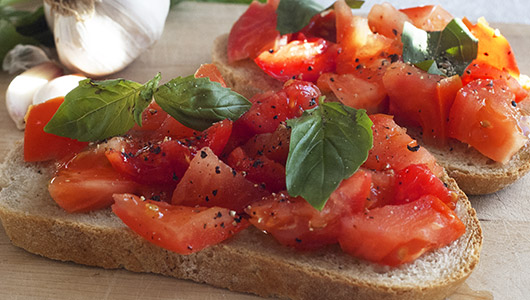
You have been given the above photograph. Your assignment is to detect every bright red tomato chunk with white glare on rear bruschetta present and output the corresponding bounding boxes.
[254,38,338,82]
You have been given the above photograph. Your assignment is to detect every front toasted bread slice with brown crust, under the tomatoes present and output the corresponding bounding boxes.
[0,143,482,300]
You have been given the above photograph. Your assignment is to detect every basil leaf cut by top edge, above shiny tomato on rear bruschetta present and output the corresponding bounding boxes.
[276,0,364,35]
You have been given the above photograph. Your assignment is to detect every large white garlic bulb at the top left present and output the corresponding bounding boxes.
[44,0,170,77]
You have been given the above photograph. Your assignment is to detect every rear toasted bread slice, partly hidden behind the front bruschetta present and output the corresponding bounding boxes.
[212,35,530,195]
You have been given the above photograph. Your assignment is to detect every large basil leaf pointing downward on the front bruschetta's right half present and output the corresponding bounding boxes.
[285,102,373,210]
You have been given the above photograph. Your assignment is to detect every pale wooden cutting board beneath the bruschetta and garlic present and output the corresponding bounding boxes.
[0,3,530,300]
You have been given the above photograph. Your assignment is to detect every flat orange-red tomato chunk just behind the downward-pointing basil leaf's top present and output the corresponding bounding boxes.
[317,73,387,114]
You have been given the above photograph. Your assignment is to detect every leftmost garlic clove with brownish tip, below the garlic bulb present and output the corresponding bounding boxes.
[6,62,63,130]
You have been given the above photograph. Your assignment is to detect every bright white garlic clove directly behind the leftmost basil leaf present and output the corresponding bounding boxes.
[33,75,86,105]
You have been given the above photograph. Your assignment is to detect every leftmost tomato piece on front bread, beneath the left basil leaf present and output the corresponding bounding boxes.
[24,97,88,161]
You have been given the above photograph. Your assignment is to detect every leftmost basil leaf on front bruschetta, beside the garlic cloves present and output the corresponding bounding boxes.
[44,79,145,141]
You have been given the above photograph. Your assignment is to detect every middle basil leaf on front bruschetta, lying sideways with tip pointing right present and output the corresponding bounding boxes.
[154,76,252,131]
